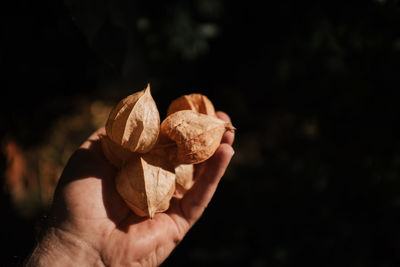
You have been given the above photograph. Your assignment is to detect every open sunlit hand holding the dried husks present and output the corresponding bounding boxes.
[27,112,234,266]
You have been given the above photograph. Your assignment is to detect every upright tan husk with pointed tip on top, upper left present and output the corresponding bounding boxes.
[106,85,160,153]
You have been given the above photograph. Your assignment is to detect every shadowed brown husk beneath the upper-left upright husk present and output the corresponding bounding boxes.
[100,135,134,169]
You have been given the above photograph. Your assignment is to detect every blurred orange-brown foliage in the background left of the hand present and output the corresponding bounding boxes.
[3,101,111,217]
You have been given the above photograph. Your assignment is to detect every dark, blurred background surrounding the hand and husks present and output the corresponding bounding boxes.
[0,0,400,267]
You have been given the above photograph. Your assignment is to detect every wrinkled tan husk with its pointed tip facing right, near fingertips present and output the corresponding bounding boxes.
[161,110,235,165]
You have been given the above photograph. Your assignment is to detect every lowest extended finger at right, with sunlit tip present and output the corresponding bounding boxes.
[181,144,234,226]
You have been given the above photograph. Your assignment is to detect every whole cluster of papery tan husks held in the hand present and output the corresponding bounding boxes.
[101,85,235,218]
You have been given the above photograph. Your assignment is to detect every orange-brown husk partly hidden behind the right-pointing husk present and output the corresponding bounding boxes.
[167,94,215,116]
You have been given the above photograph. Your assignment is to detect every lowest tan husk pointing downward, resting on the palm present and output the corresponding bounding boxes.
[116,153,175,218]
